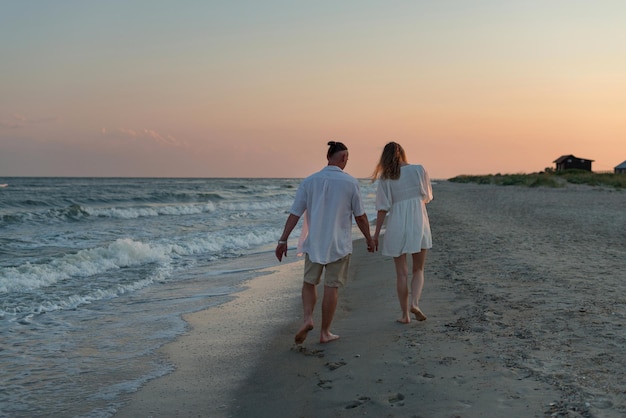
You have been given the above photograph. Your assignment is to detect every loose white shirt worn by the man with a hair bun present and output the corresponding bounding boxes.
[290,165,365,264]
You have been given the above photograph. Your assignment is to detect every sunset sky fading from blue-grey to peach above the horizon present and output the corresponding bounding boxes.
[0,0,626,178]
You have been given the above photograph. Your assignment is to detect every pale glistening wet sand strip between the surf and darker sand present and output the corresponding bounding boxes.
[114,258,304,418]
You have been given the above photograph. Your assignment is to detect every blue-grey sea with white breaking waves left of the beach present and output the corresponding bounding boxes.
[0,177,375,417]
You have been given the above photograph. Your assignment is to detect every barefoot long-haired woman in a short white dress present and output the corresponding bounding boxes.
[372,142,433,324]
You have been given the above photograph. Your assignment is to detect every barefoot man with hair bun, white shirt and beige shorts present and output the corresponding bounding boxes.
[276,141,374,344]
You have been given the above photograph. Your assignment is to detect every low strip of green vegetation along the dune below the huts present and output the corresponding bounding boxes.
[449,168,626,189]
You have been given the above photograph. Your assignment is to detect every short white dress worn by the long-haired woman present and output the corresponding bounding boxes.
[376,164,433,257]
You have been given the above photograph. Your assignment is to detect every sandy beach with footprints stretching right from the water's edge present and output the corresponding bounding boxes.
[115,182,626,418]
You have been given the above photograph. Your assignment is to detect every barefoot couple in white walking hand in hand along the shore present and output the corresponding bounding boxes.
[276,141,433,344]
